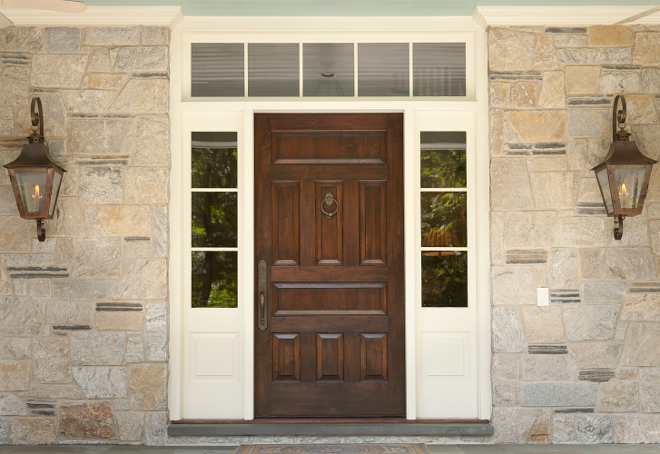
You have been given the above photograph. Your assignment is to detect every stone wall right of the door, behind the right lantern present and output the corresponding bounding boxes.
[489,26,660,443]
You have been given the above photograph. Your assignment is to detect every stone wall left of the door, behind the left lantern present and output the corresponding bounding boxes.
[0,26,170,444]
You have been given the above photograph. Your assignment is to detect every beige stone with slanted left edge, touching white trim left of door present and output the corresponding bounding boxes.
[109,78,169,113]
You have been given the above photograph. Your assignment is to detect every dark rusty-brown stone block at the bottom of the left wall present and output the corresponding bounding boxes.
[58,401,116,438]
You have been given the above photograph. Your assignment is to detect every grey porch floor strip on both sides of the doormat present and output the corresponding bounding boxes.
[0,444,660,454]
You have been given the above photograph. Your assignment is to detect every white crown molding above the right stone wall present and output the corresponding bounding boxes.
[472,5,660,30]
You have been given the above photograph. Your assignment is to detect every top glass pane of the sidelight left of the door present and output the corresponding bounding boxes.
[191,132,238,188]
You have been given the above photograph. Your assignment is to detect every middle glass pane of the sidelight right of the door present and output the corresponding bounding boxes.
[420,192,467,247]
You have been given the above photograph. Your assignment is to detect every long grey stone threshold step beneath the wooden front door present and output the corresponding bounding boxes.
[167,418,494,436]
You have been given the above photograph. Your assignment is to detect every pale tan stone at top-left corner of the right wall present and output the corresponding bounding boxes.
[488,27,536,71]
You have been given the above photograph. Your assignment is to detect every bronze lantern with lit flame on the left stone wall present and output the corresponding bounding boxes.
[5,98,66,241]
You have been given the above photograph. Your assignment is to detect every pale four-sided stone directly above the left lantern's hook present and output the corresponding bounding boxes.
[30,54,88,88]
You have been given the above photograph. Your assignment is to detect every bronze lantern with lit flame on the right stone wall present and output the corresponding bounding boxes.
[591,95,657,240]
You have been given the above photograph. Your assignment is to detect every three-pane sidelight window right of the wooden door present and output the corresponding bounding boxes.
[420,132,468,307]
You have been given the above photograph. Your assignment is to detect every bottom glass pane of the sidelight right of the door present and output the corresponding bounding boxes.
[422,251,468,307]
